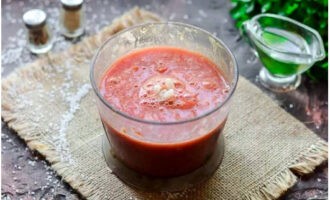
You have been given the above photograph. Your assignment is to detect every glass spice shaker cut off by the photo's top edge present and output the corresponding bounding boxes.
[60,0,85,38]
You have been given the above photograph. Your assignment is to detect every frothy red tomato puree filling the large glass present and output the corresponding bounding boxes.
[100,47,229,177]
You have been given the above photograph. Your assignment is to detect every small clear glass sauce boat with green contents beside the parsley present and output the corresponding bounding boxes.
[242,14,325,92]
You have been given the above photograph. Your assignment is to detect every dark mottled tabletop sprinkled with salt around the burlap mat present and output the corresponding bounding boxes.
[1,0,328,200]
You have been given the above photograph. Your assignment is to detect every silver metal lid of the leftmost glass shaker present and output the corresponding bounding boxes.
[23,9,47,28]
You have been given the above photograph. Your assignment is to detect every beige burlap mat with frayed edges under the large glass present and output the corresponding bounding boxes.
[2,8,327,200]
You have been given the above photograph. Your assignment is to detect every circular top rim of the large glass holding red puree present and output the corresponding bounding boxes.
[90,22,238,125]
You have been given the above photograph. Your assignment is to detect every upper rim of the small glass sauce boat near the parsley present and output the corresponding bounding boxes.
[243,13,325,61]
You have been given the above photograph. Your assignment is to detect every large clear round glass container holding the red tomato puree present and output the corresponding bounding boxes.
[90,22,238,191]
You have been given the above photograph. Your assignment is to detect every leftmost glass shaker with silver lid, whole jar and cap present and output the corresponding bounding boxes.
[23,9,53,54]
